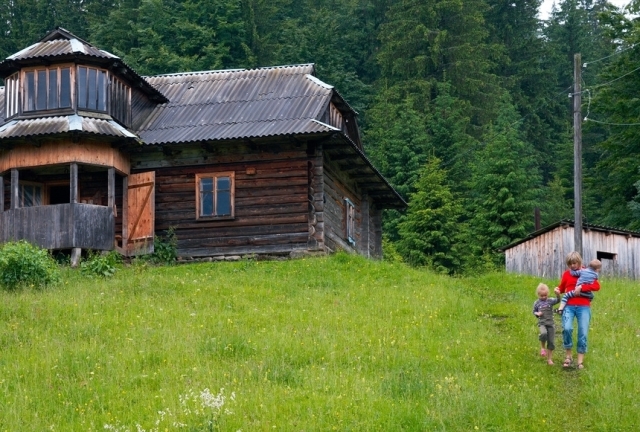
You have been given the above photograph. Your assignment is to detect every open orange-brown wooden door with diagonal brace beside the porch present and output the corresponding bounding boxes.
[122,171,156,256]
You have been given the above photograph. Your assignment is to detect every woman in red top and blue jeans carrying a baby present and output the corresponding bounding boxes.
[554,252,600,369]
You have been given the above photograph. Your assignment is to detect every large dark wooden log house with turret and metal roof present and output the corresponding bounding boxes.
[0,28,406,257]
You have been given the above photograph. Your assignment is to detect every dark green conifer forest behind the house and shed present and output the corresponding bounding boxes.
[0,0,640,273]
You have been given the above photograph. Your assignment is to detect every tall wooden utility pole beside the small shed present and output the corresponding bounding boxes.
[573,53,582,256]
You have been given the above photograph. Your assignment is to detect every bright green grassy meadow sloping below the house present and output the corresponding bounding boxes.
[0,254,640,432]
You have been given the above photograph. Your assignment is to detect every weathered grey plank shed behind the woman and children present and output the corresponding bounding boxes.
[503,220,640,279]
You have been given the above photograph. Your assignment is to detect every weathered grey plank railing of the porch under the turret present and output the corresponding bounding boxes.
[0,203,115,250]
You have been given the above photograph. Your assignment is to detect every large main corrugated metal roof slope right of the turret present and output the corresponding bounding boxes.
[137,64,336,144]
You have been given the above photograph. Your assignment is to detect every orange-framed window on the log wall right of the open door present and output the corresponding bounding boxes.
[196,172,235,219]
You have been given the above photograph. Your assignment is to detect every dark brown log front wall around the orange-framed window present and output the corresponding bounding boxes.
[131,143,309,257]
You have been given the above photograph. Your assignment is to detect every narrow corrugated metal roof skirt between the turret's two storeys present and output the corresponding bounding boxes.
[0,114,136,139]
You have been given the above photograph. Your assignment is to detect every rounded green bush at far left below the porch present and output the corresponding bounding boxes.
[0,240,60,289]
